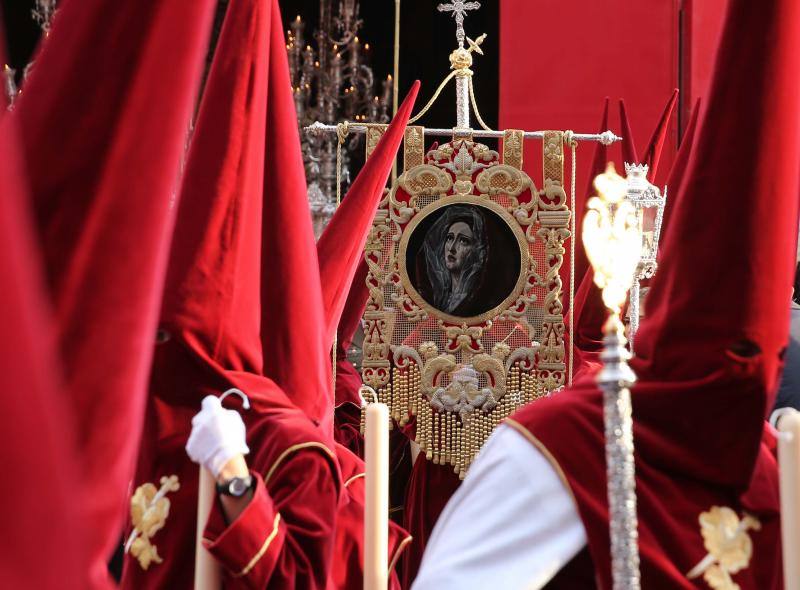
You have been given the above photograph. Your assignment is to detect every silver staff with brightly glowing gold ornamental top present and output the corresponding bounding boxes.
[583,163,642,590]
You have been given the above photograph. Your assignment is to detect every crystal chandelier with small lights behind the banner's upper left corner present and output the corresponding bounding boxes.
[286,0,393,237]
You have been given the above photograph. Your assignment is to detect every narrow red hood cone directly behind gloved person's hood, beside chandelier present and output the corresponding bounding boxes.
[261,0,333,430]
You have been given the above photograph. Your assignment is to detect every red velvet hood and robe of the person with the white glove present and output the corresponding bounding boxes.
[123,0,341,589]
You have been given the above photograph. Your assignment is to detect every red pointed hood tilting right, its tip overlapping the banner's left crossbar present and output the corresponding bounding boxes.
[317,80,419,347]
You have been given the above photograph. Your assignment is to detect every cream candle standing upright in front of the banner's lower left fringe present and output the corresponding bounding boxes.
[364,403,389,590]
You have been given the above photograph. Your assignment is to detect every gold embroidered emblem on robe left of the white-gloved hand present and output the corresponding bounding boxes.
[125,475,181,570]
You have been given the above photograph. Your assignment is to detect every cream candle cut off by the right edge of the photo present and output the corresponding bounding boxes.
[778,410,800,590]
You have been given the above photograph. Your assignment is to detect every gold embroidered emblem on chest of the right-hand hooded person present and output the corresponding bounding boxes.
[686,506,761,590]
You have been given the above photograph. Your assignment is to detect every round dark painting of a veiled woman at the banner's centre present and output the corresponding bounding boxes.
[403,202,527,319]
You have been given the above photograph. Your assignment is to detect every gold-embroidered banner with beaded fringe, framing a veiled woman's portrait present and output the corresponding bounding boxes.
[362,132,570,477]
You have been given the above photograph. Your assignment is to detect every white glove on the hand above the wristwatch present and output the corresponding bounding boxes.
[186,395,250,477]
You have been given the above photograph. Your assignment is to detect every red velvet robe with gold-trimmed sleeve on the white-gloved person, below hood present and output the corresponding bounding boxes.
[122,342,341,590]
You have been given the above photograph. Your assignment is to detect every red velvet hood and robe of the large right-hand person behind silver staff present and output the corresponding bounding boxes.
[512,0,800,589]
